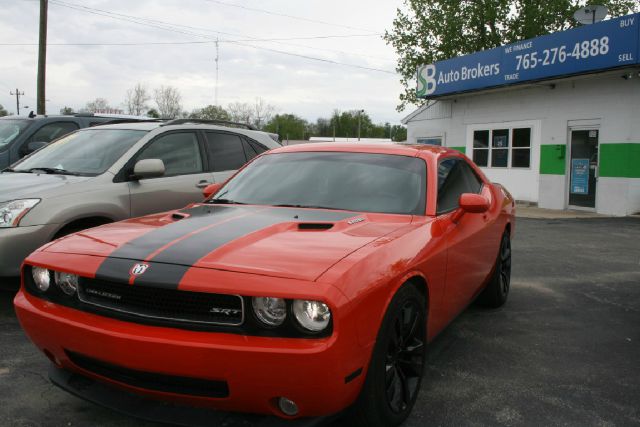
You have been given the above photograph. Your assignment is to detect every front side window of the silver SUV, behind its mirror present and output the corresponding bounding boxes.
[137,132,204,177]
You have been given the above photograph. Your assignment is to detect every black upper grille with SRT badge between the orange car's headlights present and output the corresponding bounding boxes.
[78,278,244,326]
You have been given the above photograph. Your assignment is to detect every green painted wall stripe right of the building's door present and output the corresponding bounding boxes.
[599,143,640,178]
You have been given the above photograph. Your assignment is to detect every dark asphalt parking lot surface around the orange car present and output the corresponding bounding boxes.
[0,218,640,427]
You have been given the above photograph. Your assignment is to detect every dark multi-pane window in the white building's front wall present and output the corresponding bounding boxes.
[473,128,531,168]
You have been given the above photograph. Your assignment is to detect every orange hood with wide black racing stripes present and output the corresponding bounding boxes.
[42,204,412,286]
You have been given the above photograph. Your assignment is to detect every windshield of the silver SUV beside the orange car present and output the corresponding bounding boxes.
[13,129,147,176]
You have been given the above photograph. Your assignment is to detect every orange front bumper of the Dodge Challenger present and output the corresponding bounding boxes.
[14,290,370,418]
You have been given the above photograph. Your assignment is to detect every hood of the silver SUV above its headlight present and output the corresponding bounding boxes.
[0,172,91,202]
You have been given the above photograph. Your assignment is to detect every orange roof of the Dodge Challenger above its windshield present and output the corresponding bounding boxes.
[271,142,461,157]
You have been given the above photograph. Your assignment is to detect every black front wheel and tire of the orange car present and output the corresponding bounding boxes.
[351,284,427,427]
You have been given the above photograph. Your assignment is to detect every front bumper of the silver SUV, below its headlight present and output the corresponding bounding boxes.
[0,224,58,277]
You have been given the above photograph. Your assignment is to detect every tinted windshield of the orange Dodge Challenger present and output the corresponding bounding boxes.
[210,152,426,215]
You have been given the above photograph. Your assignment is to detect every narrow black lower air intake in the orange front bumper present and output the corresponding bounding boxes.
[66,350,229,398]
